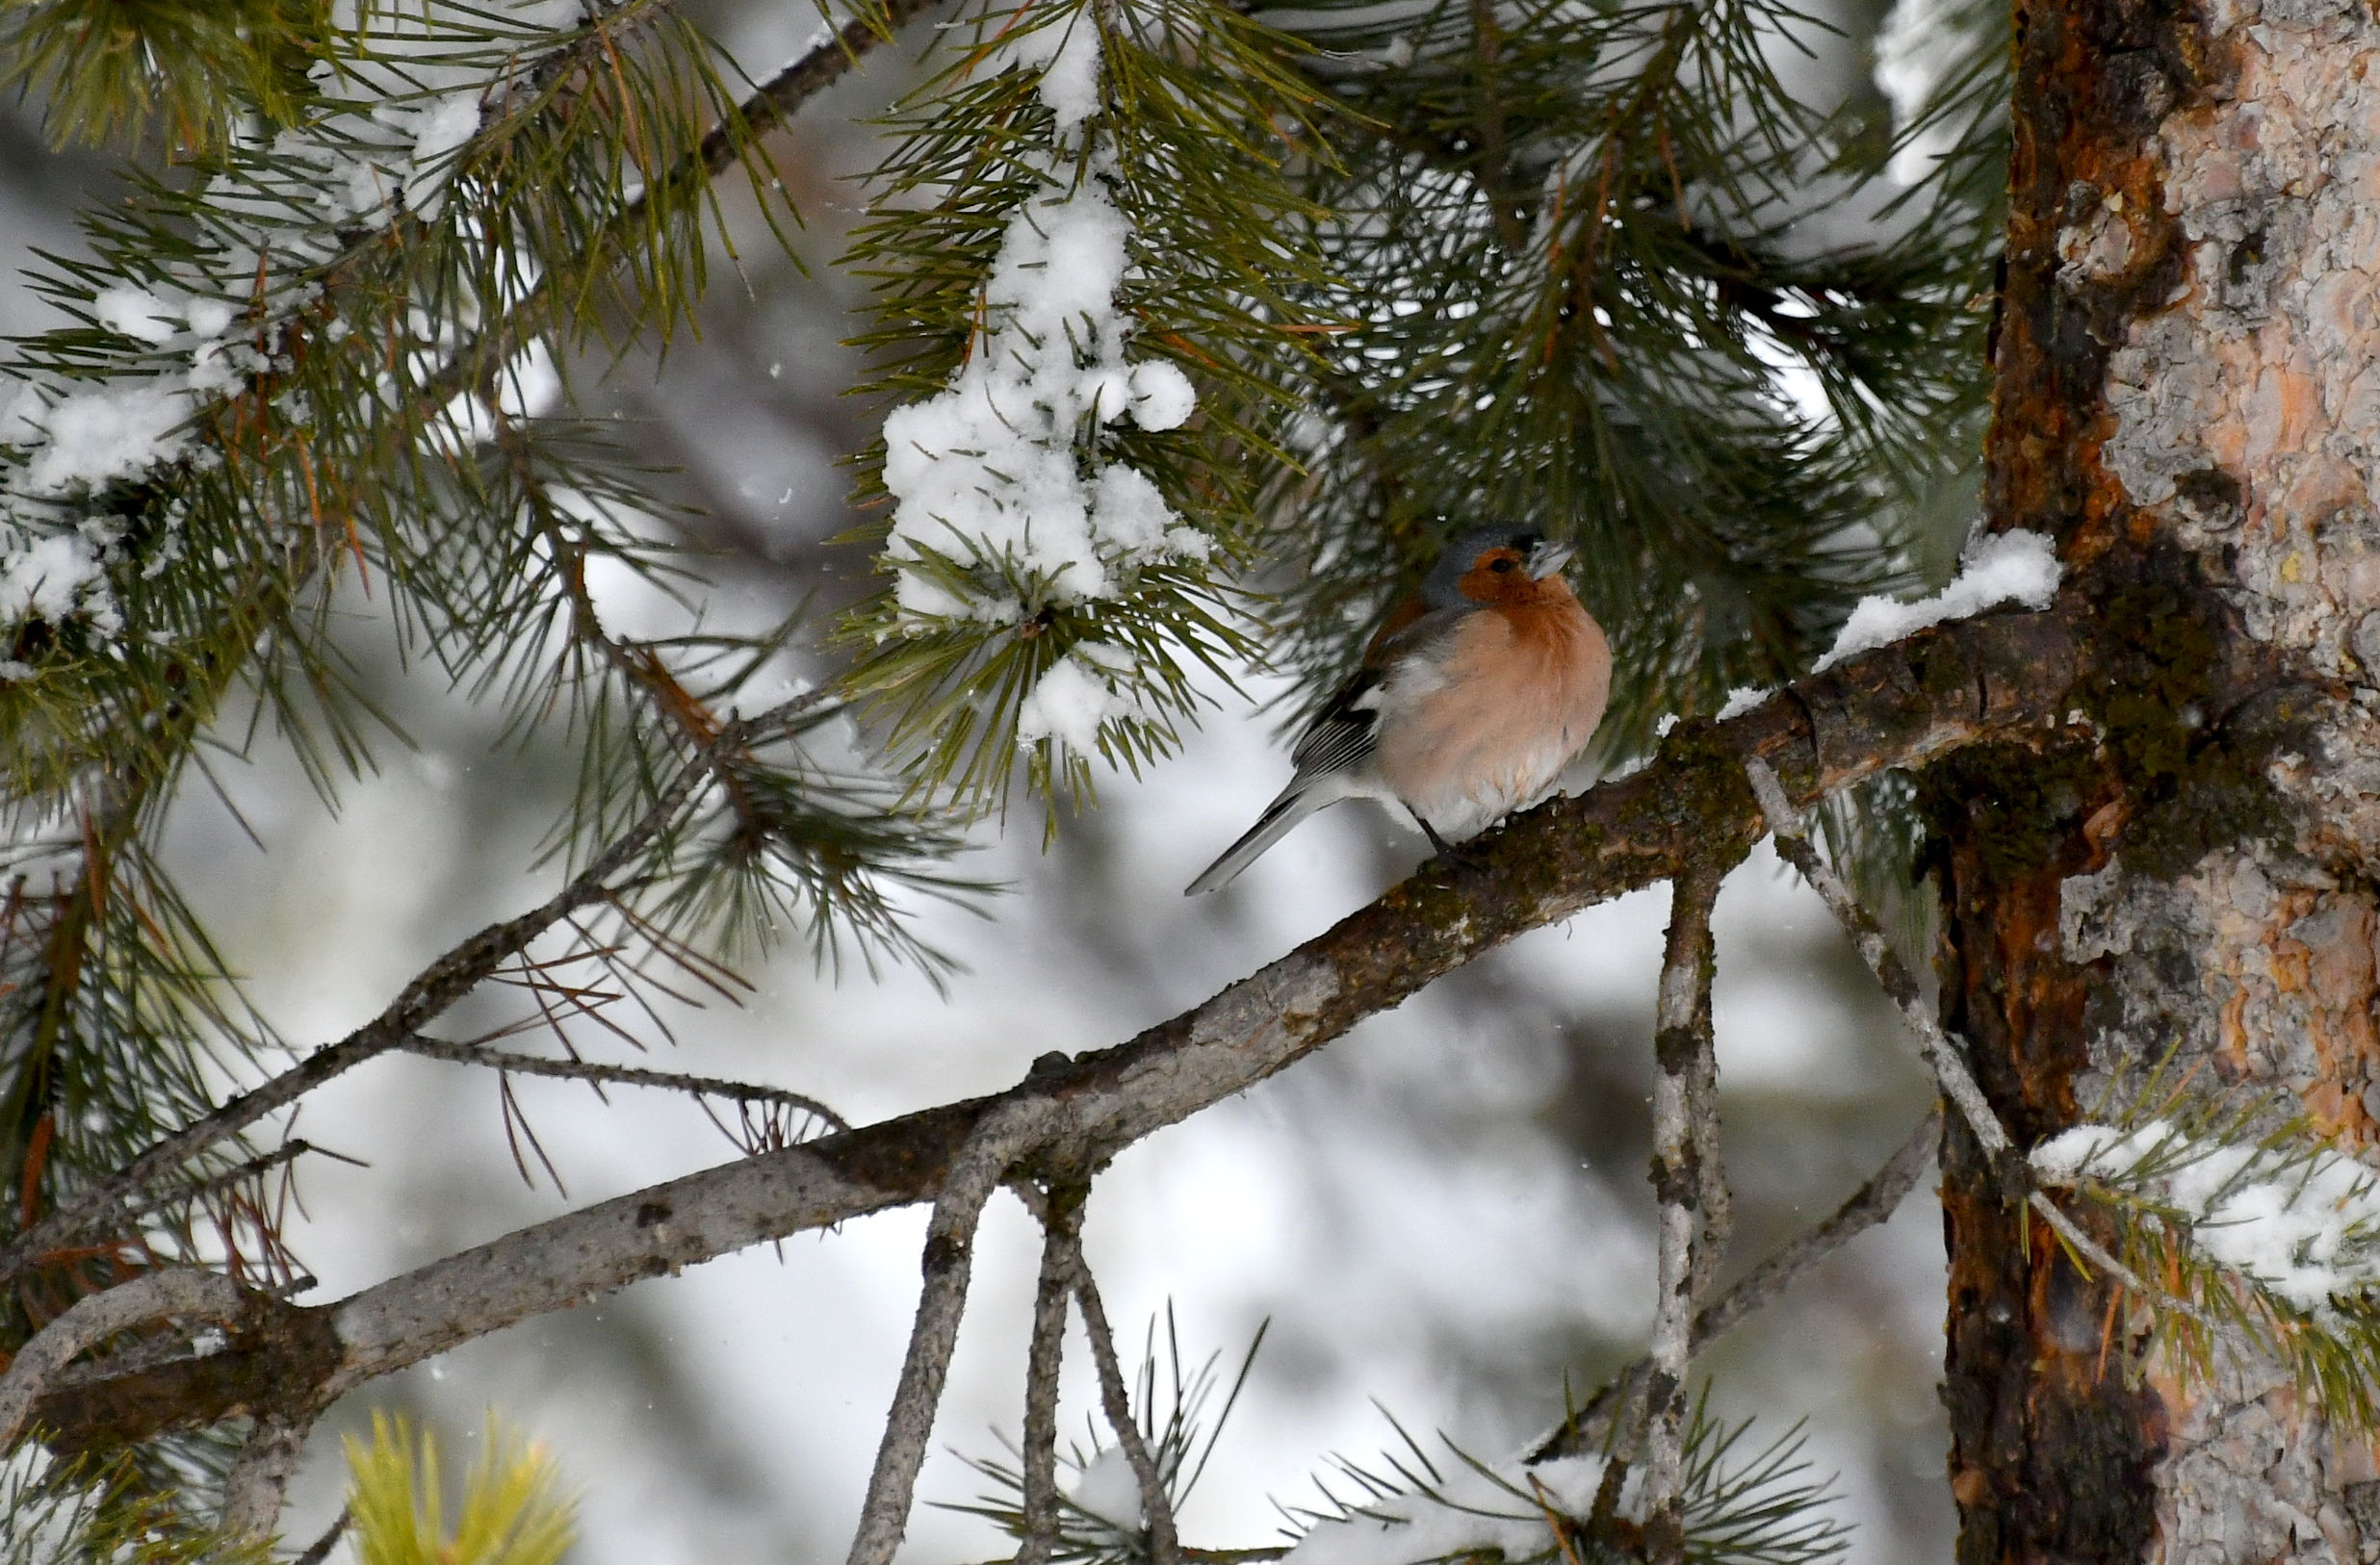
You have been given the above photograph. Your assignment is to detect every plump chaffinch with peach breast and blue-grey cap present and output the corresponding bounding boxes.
[1185,524,1612,897]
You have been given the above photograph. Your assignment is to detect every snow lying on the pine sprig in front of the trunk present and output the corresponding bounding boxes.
[2032,1120,2380,1313]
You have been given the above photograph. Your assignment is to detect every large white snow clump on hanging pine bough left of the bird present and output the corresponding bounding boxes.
[883,2,1211,752]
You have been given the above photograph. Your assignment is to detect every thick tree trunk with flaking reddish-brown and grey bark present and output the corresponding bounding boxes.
[1926,0,2380,1565]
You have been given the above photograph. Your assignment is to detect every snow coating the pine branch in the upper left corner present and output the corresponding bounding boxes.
[0,0,588,656]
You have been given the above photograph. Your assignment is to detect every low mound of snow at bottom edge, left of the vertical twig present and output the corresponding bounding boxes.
[1282,1455,1604,1565]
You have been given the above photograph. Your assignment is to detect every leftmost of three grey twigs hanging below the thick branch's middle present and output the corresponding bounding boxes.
[850,1101,1057,1565]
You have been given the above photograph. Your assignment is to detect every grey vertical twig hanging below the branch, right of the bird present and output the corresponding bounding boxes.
[1644,861,1728,1565]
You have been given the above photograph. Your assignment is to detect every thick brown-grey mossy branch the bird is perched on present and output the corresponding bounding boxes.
[42,600,2089,1437]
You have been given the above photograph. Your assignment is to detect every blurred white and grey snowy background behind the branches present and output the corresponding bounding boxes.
[0,0,1952,1565]
